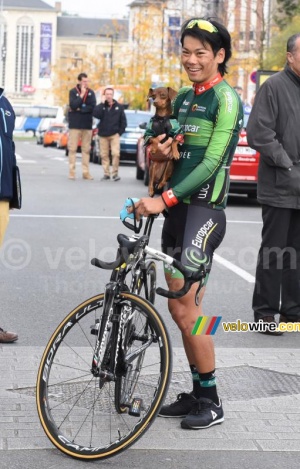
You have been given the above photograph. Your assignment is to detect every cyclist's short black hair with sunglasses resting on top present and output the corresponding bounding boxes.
[180,17,232,76]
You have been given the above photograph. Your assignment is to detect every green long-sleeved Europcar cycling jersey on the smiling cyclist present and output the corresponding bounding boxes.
[169,80,243,209]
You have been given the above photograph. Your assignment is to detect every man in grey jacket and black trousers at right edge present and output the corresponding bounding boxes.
[247,33,300,335]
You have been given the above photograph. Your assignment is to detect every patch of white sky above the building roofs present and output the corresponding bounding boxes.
[44,0,132,19]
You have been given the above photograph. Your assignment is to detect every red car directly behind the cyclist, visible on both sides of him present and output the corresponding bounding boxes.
[136,106,259,198]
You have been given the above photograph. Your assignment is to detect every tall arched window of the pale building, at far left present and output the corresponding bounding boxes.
[15,17,34,93]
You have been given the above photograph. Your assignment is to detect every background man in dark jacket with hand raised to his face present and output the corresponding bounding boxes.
[68,73,96,179]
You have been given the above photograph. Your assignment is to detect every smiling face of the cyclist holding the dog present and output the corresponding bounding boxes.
[181,36,225,83]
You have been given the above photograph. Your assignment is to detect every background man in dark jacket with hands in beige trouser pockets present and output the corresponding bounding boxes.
[93,88,127,181]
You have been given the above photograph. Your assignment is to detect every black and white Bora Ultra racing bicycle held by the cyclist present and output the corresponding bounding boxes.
[36,198,205,460]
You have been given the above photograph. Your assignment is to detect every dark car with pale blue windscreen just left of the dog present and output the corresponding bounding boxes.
[120,109,153,161]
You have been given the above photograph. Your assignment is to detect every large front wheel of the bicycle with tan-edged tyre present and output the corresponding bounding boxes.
[36,292,172,460]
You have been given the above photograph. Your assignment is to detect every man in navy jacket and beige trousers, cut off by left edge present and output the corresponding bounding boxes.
[0,88,18,343]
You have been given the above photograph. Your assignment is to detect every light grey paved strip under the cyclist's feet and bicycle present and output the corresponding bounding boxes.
[0,344,300,452]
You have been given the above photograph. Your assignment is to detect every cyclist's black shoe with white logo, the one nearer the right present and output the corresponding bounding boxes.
[181,397,224,430]
